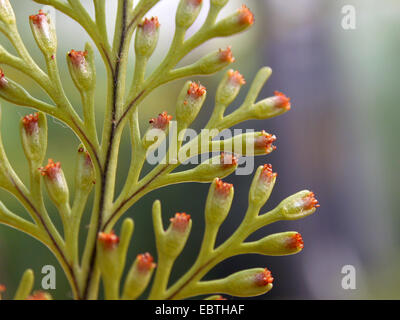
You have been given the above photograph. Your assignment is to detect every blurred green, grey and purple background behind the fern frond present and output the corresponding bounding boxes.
[0,0,400,299]
